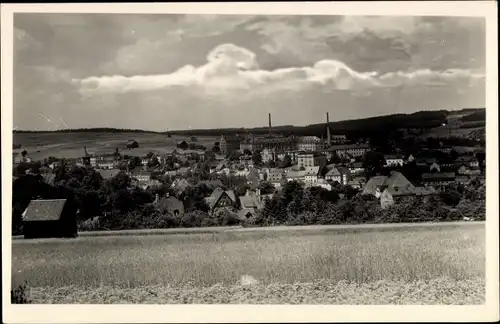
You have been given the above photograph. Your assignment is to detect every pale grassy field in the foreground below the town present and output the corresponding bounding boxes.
[12,223,485,304]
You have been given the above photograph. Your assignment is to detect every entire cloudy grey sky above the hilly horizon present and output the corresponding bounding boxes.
[13,13,486,131]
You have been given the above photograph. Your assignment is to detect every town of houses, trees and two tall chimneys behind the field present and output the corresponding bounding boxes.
[13,112,485,237]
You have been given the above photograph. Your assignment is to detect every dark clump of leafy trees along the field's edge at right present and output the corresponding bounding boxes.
[248,181,486,226]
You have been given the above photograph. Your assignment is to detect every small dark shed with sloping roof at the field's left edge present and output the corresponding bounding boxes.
[23,199,78,239]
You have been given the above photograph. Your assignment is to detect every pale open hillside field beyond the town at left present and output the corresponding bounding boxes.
[13,132,217,160]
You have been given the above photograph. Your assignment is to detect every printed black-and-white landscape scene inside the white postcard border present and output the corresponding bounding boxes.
[2,2,498,320]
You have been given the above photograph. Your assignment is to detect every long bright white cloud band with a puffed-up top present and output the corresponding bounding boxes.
[74,44,483,95]
